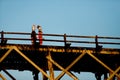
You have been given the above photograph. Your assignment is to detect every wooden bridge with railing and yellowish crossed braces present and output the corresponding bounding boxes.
[0,31,120,80]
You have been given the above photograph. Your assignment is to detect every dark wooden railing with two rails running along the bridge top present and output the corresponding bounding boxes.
[0,31,120,48]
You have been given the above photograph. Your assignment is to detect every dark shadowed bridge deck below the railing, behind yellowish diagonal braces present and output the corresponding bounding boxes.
[0,45,120,72]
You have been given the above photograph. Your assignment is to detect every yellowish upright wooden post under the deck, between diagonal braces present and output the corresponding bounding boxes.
[47,51,54,80]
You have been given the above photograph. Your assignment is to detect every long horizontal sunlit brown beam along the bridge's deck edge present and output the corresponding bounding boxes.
[0,44,120,55]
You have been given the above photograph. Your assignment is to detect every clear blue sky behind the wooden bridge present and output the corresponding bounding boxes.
[0,0,120,80]
